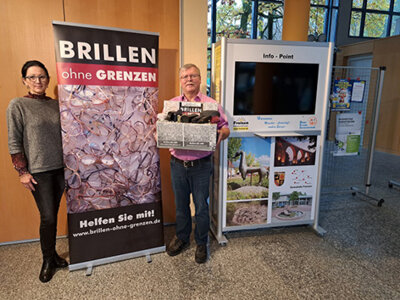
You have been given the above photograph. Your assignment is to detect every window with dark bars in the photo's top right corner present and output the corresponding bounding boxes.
[349,0,400,38]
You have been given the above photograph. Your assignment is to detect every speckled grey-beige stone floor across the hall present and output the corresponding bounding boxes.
[0,153,400,299]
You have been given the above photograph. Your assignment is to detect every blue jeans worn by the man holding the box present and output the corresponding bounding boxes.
[171,156,212,245]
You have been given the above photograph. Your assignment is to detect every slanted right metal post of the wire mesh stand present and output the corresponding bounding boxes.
[365,67,386,195]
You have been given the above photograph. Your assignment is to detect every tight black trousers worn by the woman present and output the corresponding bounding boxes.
[32,169,65,259]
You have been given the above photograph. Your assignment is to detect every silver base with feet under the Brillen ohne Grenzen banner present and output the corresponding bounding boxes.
[68,246,165,276]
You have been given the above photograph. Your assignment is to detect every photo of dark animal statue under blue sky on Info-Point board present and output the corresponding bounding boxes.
[226,137,271,201]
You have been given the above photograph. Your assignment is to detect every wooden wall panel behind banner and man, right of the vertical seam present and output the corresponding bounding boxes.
[64,0,179,223]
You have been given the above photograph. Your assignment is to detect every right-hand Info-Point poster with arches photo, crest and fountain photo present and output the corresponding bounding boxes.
[270,136,318,224]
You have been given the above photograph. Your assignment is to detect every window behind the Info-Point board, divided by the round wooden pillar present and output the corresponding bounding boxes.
[207,0,340,92]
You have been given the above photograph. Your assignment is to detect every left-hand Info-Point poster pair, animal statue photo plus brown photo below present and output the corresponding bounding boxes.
[225,137,271,226]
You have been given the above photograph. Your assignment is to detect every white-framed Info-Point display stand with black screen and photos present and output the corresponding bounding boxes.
[210,38,333,245]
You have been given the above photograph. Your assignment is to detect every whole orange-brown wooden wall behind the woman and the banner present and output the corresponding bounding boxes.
[0,0,179,243]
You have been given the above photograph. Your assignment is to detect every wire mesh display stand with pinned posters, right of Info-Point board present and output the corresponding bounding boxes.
[322,66,385,206]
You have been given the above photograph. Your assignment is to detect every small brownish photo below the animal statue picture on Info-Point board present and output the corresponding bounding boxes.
[226,200,268,226]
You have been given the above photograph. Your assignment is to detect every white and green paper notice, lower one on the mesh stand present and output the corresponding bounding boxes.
[333,113,362,156]
